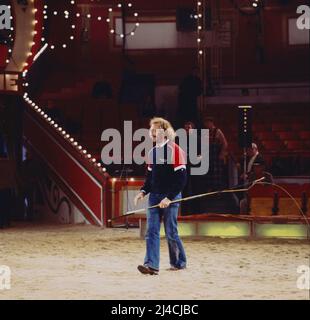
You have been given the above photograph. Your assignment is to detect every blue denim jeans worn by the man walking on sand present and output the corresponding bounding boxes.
[144,193,186,270]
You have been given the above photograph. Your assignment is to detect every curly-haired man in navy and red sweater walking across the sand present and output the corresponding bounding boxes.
[135,118,186,275]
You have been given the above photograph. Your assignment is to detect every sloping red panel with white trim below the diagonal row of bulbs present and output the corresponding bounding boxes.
[24,110,106,226]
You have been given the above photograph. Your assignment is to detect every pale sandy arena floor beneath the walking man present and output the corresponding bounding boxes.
[0,225,310,299]
